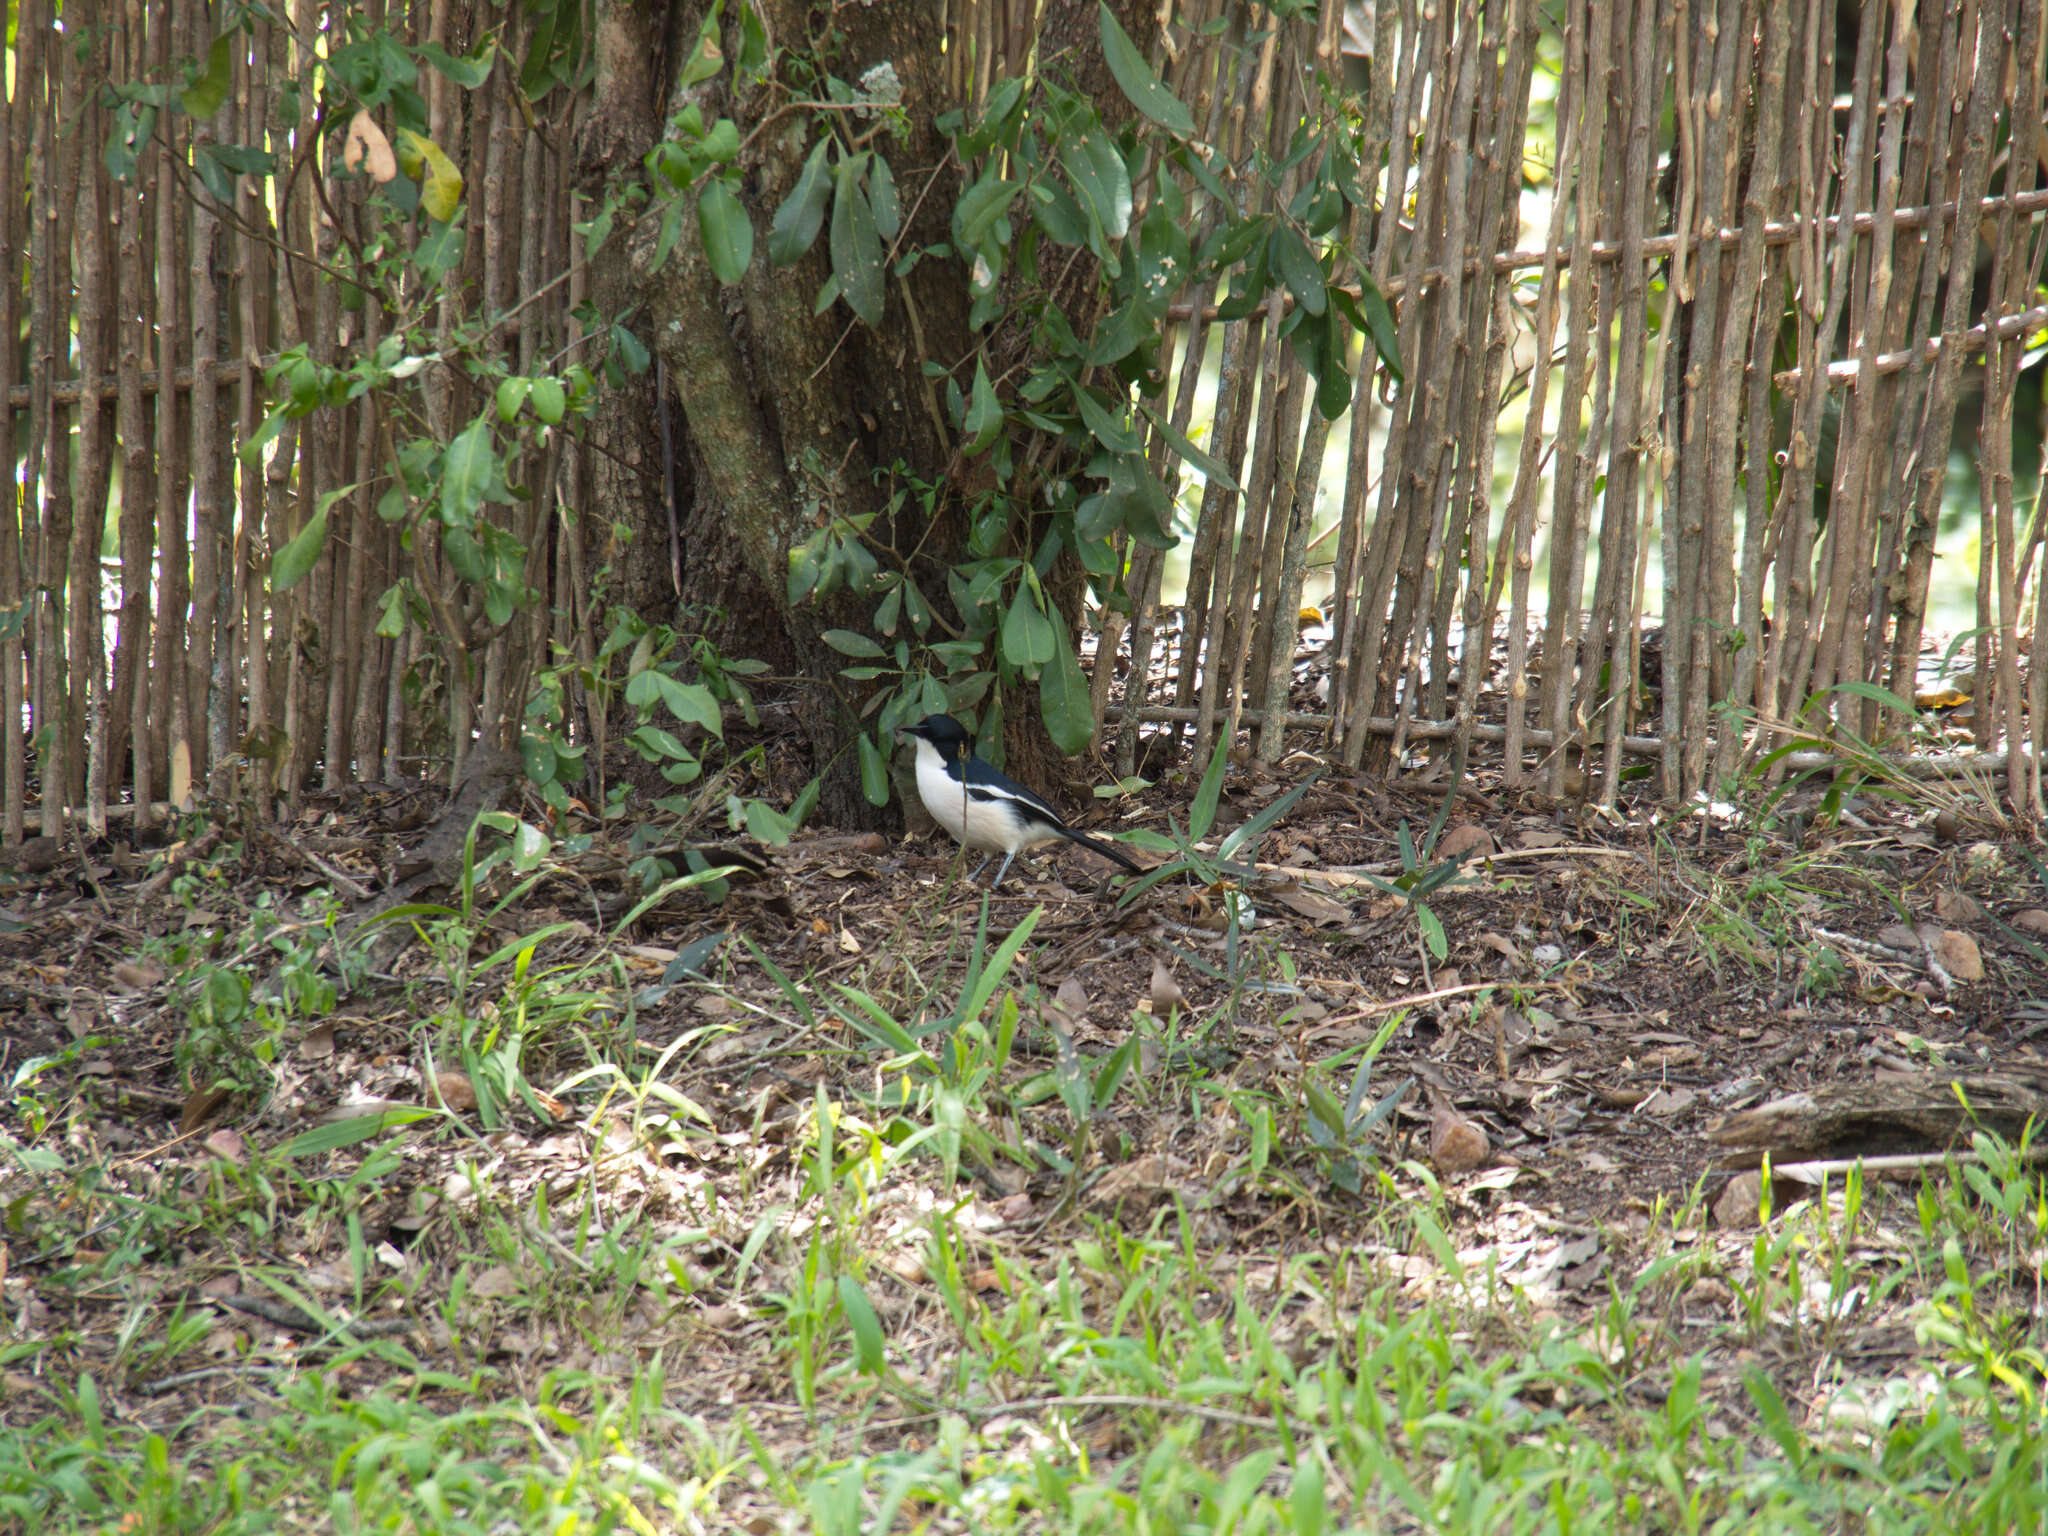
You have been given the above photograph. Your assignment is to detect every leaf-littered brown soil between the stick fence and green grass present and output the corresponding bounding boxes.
[0,704,2048,1518]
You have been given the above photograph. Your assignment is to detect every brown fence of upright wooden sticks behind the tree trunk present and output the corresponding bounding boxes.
[0,0,2048,856]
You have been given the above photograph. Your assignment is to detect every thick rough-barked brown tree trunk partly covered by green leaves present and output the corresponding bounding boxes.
[578,0,1151,825]
